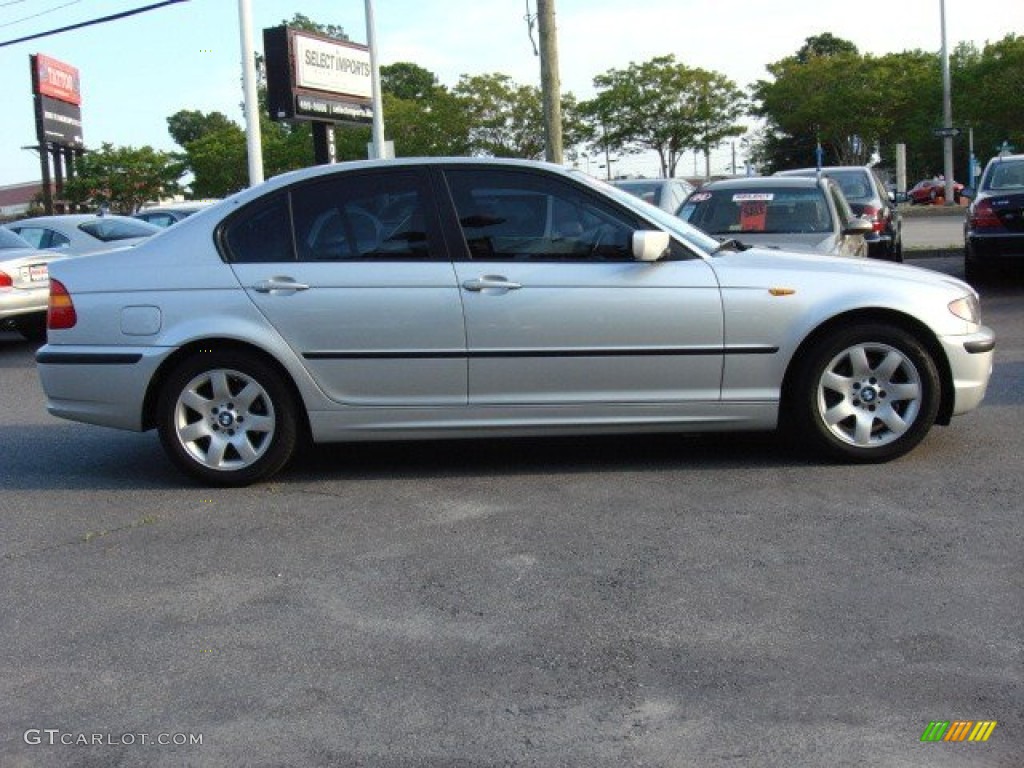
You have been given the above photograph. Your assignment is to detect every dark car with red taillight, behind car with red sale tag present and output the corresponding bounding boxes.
[775,165,903,261]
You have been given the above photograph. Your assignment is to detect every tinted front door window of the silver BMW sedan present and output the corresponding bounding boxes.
[445,169,637,261]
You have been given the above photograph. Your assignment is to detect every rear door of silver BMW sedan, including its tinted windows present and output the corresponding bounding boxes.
[224,171,467,406]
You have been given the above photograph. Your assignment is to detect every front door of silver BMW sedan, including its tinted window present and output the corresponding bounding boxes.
[445,170,723,404]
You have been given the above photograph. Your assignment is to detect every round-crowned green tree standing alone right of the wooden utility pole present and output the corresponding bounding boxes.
[581,54,745,177]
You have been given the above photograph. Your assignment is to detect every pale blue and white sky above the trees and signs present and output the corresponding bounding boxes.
[0,0,1024,186]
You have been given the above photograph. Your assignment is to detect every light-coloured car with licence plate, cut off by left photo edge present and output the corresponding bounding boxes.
[0,226,63,341]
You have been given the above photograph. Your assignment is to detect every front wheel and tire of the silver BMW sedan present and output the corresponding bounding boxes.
[788,324,940,464]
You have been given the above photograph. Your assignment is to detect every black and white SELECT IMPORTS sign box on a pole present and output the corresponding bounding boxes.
[263,27,373,123]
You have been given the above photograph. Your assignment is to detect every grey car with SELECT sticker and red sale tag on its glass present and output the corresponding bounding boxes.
[679,176,871,257]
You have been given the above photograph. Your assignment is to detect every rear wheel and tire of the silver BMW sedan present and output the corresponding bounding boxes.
[157,351,298,486]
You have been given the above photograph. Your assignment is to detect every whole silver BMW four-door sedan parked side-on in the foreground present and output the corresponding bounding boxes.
[36,158,995,485]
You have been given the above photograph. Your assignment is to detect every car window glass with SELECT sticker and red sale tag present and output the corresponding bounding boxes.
[679,186,831,234]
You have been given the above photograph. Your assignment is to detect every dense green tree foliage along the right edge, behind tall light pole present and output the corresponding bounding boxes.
[752,33,1024,179]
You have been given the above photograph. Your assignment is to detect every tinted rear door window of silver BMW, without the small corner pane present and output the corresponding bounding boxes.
[292,172,431,261]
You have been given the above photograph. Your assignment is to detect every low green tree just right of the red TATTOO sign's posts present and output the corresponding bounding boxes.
[65,143,184,213]
